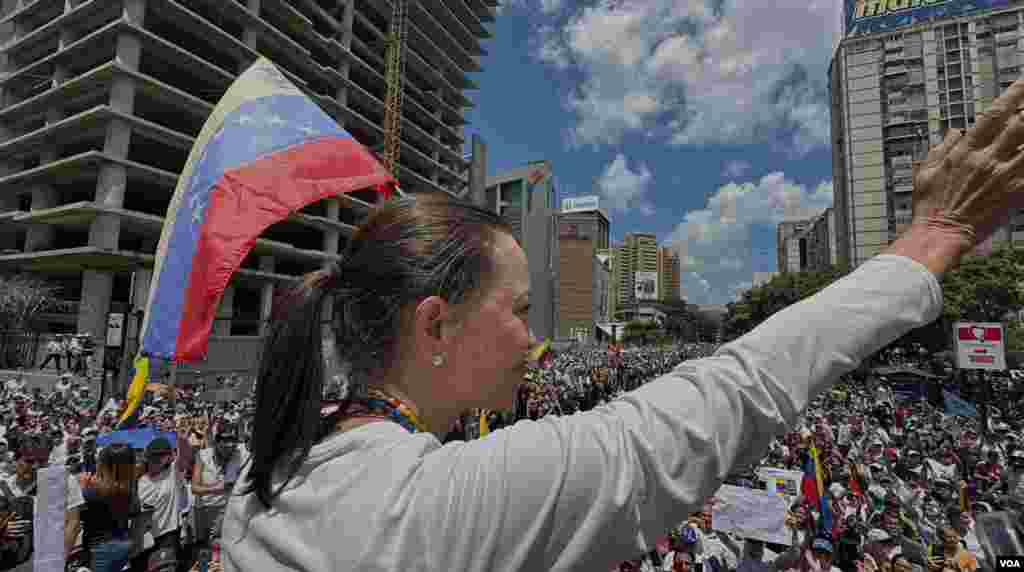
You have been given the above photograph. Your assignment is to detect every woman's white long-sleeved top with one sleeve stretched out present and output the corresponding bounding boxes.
[222,256,942,572]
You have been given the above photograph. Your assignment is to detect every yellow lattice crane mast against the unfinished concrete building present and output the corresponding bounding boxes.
[384,0,409,181]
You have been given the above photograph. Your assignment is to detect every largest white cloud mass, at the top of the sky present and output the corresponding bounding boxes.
[535,0,842,153]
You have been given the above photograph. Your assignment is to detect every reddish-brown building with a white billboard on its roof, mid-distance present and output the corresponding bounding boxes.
[557,204,609,340]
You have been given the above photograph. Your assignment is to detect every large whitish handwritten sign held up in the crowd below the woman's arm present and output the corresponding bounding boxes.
[712,485,792,545]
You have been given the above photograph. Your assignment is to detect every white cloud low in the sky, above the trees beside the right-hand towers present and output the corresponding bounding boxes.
[663,172,833,304]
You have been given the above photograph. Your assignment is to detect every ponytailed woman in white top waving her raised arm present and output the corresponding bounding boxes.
[222,81,1024,572]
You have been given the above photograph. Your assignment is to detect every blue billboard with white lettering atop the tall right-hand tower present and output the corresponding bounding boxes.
[845,0,1010,37]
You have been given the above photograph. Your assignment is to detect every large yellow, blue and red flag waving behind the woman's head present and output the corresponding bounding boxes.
[139,58,395,361]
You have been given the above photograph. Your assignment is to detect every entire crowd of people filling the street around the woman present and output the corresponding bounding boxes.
[0,344,1024,572]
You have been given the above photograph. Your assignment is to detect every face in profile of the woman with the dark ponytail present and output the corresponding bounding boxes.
[446,232,535,409]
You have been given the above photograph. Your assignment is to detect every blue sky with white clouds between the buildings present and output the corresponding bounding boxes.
[466,0,841,304]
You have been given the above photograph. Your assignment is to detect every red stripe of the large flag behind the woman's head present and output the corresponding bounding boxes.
[175,137,393,361]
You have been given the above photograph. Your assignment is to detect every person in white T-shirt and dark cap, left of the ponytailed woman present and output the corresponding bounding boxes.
[132,437,187,569]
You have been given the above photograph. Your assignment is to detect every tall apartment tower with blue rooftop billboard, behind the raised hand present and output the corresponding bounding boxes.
[829,0,1024,265]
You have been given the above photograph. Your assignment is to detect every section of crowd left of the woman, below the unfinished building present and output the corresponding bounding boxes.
[0,371,251,572]
